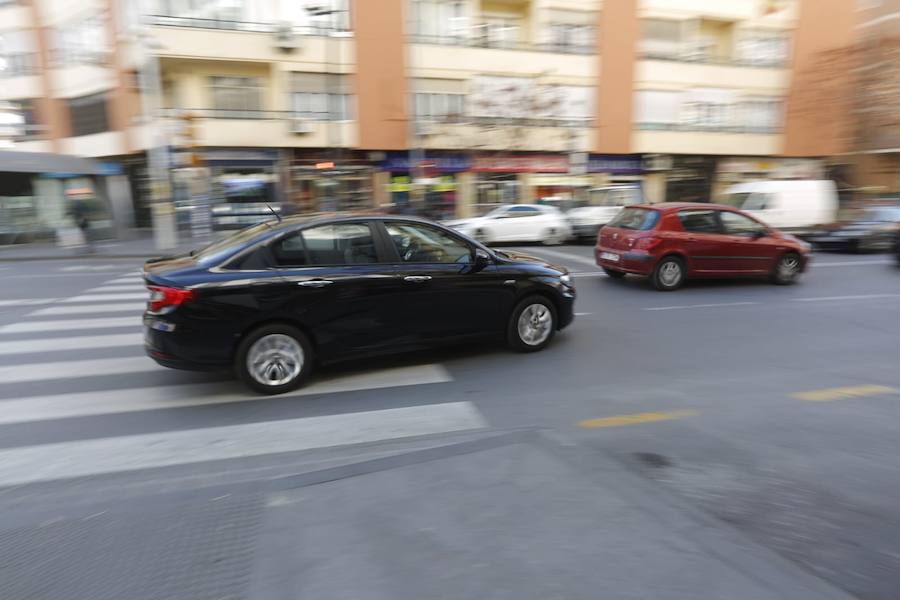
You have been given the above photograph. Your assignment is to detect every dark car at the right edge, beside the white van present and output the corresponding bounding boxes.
[809,206,900,252]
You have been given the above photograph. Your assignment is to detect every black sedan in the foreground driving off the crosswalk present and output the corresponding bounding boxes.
[144,216,575,394]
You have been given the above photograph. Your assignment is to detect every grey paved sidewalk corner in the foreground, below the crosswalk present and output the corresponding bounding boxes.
[0,430,852,600]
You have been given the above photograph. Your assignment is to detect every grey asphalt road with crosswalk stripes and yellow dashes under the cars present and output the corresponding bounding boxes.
[0,246,900,600]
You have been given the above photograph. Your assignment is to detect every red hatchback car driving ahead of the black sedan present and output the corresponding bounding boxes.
[594,202,810,291]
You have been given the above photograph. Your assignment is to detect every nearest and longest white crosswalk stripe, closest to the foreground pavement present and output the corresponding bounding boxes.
[0,402,487,486]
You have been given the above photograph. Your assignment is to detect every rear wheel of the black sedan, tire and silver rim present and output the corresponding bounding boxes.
[234,323,315,395]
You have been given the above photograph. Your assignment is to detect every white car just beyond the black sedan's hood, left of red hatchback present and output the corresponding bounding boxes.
[446,204,572,246]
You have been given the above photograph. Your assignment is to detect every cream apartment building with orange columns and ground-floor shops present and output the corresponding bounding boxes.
[0,0,855,239]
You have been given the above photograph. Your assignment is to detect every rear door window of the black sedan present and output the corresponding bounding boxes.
[272,223,378,267]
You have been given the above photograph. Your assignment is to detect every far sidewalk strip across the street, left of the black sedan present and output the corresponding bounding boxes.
[0,231,209,262]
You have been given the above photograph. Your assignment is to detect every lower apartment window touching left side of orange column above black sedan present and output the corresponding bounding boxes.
[291,73,353,121]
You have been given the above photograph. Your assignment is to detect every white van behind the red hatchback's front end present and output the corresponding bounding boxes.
[725,180,838,233]
